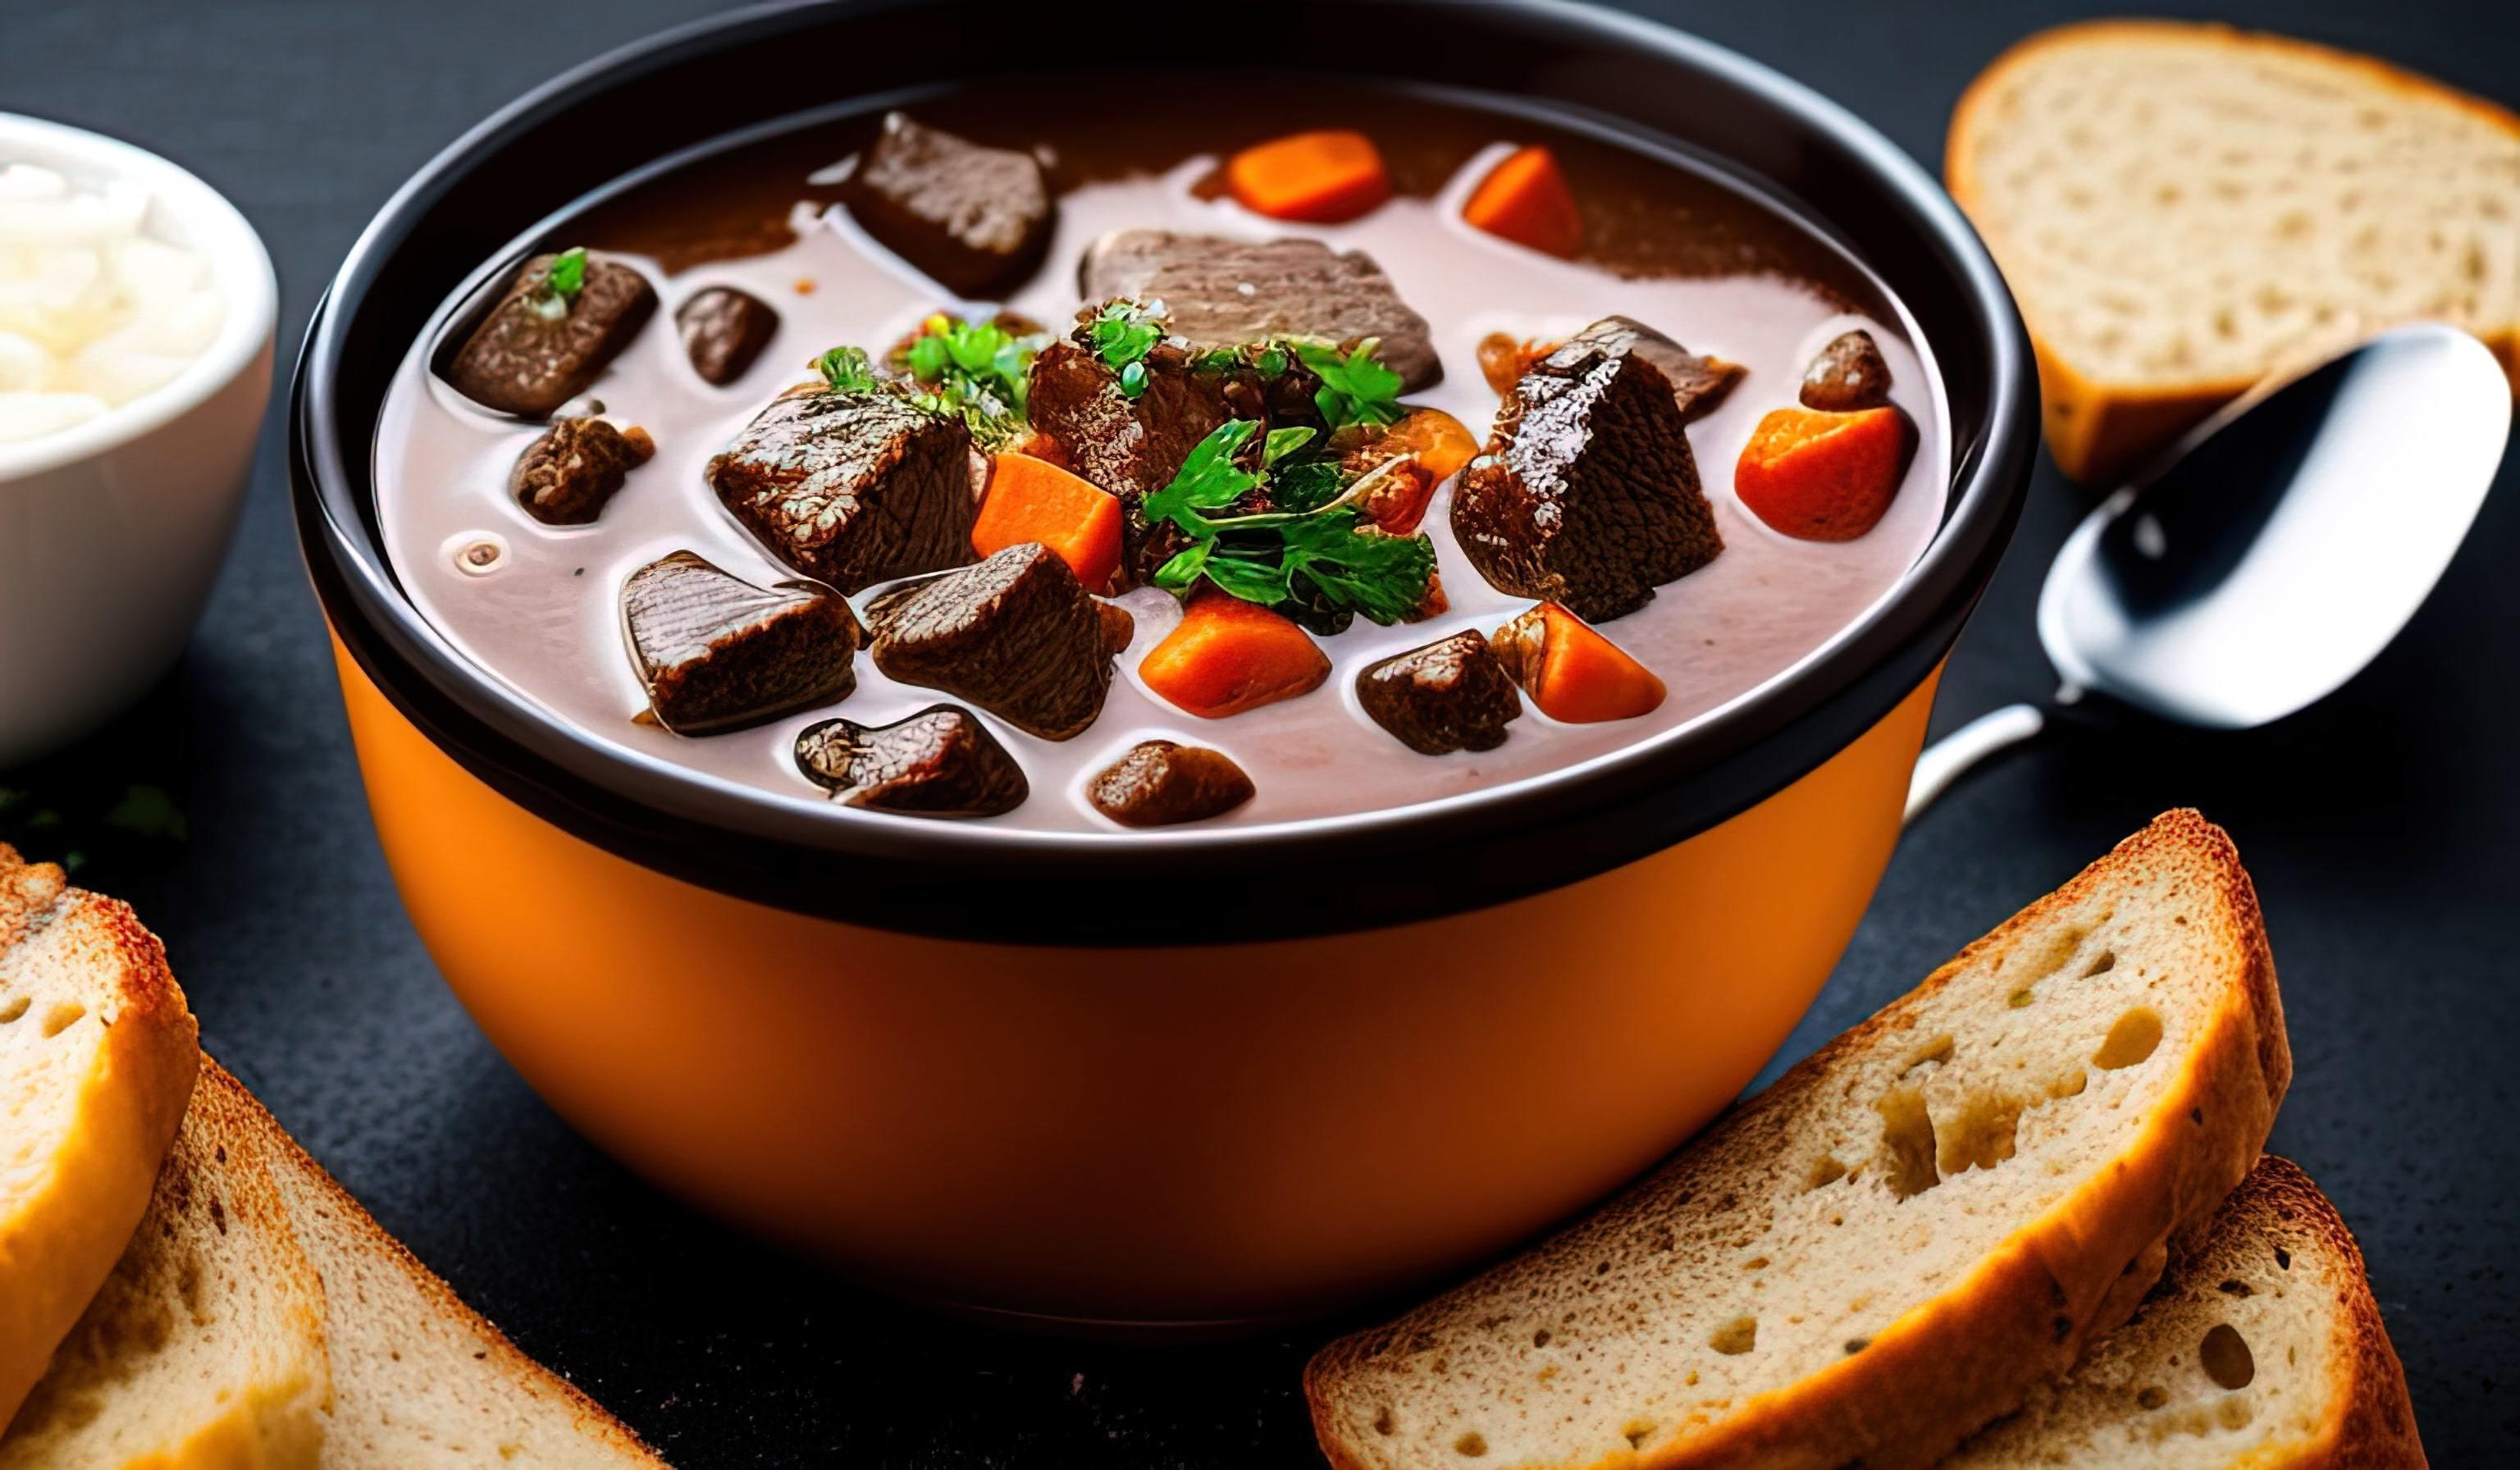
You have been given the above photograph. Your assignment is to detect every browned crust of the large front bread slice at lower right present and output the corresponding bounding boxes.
[1305,810,2290,1470]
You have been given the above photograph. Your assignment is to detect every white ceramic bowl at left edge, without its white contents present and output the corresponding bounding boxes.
[0,113,280,769]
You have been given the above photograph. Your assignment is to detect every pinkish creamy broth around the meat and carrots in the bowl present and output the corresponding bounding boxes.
[376,149,1951,842]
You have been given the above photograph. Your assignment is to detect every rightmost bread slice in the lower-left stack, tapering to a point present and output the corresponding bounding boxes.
[254,1074,665,1470]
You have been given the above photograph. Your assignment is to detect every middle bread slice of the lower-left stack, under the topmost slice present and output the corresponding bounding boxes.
[0,1057,330,1470]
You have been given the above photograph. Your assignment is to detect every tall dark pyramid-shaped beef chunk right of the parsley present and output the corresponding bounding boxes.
[1451,317,1723,623]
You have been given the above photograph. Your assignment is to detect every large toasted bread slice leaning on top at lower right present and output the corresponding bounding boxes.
[1305,812,2290,1470]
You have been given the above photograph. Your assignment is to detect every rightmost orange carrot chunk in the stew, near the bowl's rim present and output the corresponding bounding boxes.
[1734,409,1915,542]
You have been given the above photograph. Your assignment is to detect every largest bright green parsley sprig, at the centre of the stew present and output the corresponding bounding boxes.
[1142,418,1434,630]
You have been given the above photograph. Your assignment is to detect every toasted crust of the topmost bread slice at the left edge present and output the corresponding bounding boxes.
[0,842,199,1425]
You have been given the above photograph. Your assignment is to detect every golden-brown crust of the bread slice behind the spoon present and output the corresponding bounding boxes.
[1943,21,2520,489]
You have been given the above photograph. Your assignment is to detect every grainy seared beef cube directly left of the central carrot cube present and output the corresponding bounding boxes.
[708,383,980,592]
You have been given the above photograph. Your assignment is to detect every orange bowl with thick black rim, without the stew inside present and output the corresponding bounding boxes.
[292,0,2036,1326]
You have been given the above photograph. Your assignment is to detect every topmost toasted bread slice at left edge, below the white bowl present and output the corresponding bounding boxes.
[0,842,199,1425]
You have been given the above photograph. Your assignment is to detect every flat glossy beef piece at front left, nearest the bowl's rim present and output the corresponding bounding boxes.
[797,704,1030,817]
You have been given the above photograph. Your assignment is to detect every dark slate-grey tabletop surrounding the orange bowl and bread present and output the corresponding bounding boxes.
[0,0,2520,1468]
